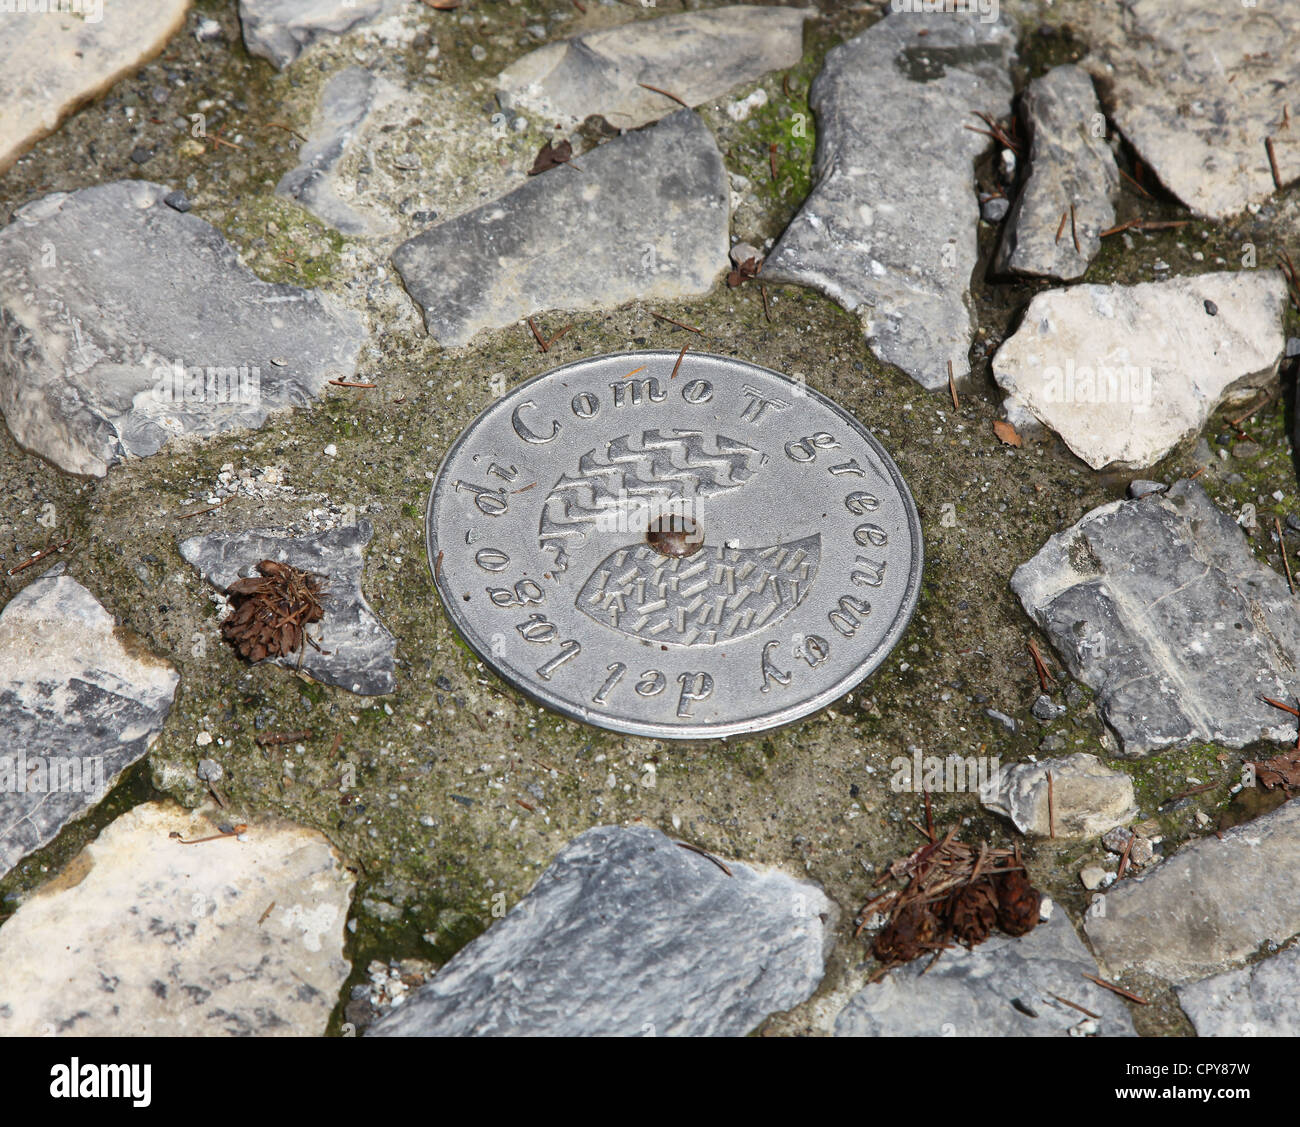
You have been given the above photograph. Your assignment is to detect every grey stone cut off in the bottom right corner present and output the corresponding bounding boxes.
[1178,946,1300,1037]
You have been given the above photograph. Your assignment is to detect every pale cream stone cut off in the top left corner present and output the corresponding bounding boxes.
[0,0,190,173]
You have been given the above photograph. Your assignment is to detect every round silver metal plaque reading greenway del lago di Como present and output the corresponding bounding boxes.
[426,352,922,738]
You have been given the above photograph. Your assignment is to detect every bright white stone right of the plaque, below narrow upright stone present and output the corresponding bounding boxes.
[993,270,1287,469]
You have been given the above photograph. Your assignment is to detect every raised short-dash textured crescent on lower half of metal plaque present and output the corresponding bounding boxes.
[577,534,822,646]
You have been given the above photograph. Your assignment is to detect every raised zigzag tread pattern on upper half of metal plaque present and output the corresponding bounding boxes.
[537,430,761,568]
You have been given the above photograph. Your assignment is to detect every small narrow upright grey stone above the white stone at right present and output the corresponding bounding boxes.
[997,65,1119,281]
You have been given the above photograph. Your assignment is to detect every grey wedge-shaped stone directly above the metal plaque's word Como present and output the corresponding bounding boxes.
[393,109,729,346]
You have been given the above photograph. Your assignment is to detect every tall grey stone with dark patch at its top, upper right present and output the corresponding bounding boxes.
[763,12,1015,389]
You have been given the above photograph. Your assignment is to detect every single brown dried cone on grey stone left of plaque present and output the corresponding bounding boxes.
[221,559,325,662]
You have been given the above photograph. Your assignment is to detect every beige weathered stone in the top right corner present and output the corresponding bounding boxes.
[1080,0,1300,220]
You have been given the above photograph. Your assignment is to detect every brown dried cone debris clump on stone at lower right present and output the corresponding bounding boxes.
[858,831,1041,966]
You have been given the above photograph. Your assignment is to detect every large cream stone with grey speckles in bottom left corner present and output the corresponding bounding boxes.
[0,803,352,1037]
